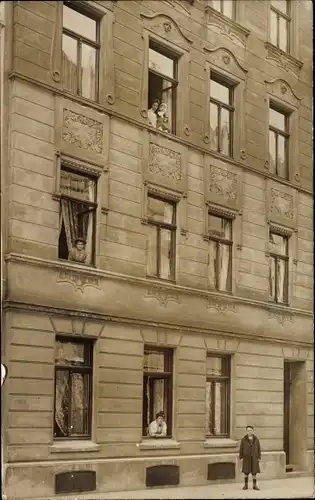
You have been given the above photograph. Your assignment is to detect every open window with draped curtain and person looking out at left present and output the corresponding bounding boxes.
[58,168,97,264]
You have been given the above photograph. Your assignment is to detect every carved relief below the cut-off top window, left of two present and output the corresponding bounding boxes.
[205,5,250,45]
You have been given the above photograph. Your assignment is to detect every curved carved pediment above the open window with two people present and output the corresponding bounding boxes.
[140,13,193,50]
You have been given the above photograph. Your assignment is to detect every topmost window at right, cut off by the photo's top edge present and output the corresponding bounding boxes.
[270,0,291,52]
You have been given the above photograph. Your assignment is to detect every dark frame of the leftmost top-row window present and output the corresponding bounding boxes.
[61,0,101,102]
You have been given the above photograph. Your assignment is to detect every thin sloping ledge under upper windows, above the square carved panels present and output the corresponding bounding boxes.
[9,71,313,196]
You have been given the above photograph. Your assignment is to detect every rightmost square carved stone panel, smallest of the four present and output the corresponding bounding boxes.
[267,181,296,229]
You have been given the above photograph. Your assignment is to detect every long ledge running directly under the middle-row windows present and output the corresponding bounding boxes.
[4,253,313,318]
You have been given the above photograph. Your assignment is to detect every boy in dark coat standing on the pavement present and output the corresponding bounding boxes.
[239,425,261,490]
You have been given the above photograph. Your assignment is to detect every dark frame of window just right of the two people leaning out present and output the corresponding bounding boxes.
[209,70,235,158]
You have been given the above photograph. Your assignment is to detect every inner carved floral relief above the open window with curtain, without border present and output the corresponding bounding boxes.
[62,108,103,154]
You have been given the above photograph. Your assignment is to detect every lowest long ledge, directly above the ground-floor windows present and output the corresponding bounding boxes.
[3,301,313,348]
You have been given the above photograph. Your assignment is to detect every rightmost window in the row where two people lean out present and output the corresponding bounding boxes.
[269,107,289,179]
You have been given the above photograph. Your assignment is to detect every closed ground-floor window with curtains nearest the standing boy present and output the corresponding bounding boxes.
[206,355,230,437]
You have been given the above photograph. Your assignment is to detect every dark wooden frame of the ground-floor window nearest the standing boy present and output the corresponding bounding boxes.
[206,352,231,439]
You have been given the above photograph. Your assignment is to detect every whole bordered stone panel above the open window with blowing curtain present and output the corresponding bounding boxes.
[56,99,109,166]
